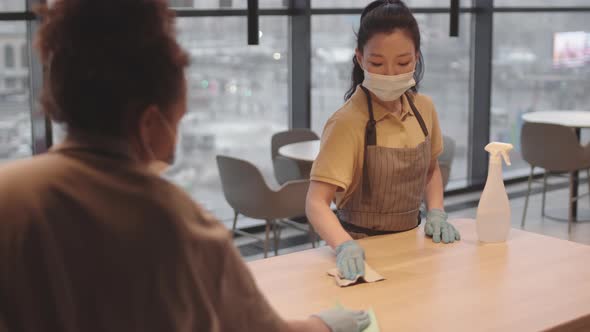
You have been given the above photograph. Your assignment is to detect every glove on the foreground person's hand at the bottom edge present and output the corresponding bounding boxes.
[314,308,371,332]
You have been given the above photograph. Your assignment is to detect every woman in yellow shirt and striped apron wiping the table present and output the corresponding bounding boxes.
[307,0,460,279]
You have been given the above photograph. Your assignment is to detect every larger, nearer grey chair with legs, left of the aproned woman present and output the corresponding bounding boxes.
[217,156,315,258]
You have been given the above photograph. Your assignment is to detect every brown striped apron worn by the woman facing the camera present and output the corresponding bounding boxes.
[338,85,431,239]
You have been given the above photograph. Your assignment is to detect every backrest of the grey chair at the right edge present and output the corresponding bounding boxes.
[520,122,590,172]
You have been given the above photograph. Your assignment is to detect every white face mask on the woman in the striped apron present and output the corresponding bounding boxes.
[363,70,416,101]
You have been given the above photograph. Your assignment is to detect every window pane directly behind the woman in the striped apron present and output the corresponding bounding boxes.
[312,14,471,187]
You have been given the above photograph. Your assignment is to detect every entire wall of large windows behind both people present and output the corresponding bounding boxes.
[0,0,590,202]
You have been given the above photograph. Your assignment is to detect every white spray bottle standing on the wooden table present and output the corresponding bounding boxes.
[476,142,513,242]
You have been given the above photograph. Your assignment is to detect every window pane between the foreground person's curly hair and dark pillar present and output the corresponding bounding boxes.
[169,16,289,220]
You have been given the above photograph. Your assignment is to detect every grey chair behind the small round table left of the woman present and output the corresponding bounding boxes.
[270,129,319,184]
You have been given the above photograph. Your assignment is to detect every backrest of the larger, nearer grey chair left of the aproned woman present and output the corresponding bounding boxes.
[217,156,273,219]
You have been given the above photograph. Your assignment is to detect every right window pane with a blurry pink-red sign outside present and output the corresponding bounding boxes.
[490,13,590,176]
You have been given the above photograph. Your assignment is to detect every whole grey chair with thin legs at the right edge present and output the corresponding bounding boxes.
[520,122,590,234]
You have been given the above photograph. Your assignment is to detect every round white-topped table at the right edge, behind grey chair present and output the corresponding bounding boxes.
[522,111,590,220]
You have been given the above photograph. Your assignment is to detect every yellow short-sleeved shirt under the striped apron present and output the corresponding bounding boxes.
[311,87,443,208]
